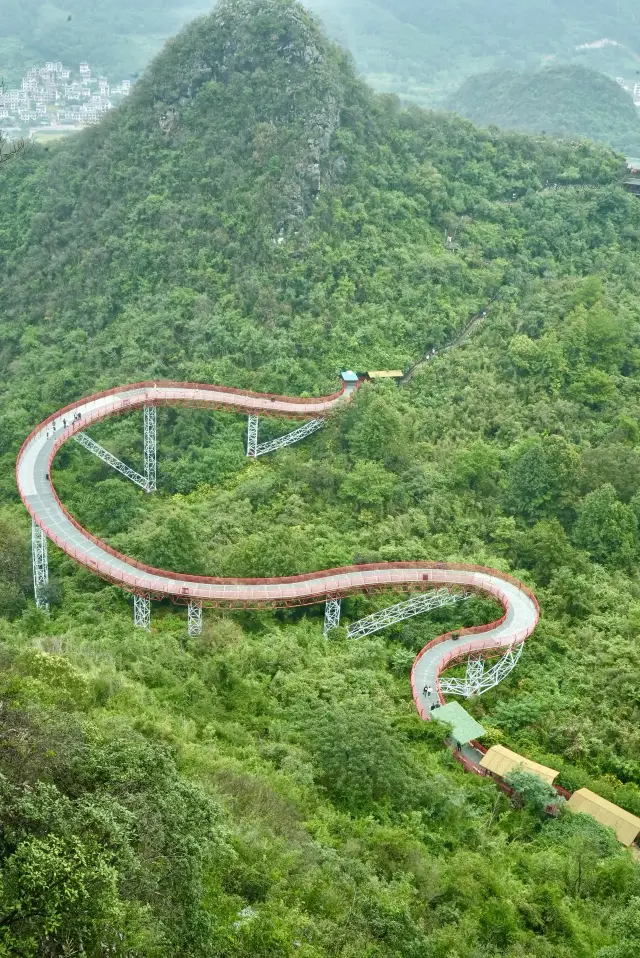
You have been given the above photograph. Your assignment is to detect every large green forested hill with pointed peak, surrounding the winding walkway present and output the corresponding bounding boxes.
[0,0,640,958]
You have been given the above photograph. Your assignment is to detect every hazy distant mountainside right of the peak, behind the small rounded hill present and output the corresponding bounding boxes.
[310,0,640,105]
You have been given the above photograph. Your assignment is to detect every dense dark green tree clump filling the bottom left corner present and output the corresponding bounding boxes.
[0,664,229,956]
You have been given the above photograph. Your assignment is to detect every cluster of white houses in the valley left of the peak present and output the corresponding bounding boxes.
[0,61,131,139]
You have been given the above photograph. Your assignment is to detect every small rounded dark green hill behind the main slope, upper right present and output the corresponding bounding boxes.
[446,66,640,155]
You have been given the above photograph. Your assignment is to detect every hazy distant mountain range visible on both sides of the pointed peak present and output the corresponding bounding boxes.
[0,0,640,106]
